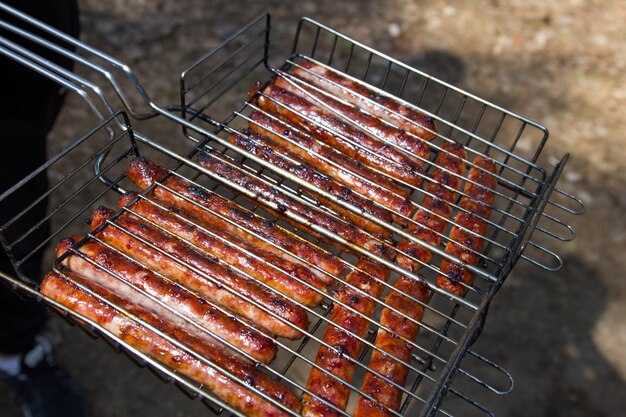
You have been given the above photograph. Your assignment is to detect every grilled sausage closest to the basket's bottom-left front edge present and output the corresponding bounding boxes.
[41,272,300,417]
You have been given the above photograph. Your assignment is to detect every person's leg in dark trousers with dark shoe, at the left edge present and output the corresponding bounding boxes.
[0,0,89,417]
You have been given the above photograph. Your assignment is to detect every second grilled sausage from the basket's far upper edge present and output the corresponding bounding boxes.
[274,75,430,166]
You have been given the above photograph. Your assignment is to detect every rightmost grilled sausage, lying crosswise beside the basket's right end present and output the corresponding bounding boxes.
[437,156,497,297]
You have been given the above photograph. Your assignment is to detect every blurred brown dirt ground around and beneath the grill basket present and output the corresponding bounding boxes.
[0,0,626,417]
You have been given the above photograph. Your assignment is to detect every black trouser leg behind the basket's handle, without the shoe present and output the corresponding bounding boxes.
[0,0,78,354]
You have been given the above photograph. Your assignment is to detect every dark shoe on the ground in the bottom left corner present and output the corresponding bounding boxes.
[0,337,90,417]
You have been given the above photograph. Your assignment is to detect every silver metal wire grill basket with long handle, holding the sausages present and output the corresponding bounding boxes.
[0,4,584,416]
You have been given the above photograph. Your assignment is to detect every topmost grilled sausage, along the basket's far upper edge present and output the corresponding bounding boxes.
[290,61,436,141]
